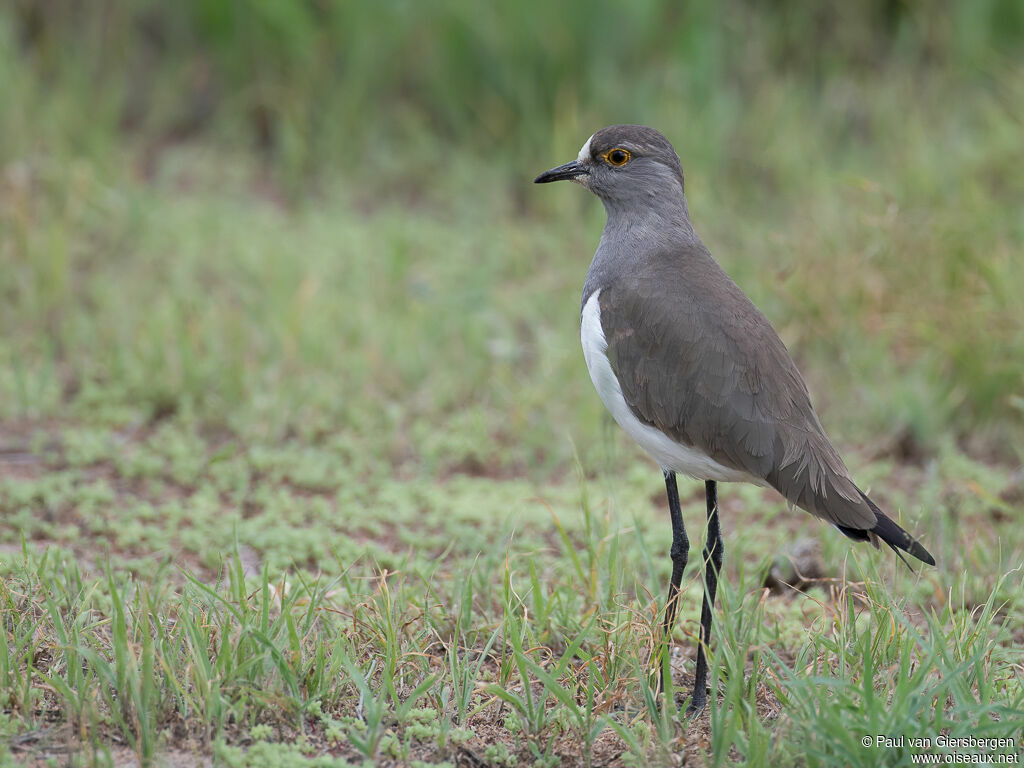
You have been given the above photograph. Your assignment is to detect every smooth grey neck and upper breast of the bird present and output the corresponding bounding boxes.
[581,196,700,309]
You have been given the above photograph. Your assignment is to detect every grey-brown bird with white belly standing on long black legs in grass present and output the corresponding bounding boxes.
[535,125,935,717]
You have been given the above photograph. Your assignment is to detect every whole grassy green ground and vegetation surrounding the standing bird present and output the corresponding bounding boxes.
[0,0,1024,767]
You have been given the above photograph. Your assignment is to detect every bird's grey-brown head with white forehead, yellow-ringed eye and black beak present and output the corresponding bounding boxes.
[534,125,683,208]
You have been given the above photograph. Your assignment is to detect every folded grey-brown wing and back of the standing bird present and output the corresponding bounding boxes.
[599,248,877,530]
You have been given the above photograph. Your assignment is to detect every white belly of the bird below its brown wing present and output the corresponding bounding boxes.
[580,291,764,485]
